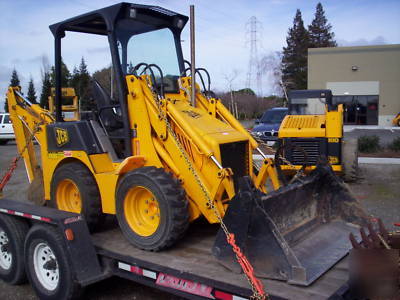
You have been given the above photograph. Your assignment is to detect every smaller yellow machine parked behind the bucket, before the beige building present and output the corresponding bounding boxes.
[277,90,358,181]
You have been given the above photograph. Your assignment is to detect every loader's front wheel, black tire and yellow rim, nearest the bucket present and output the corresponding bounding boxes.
[117,167,189,251]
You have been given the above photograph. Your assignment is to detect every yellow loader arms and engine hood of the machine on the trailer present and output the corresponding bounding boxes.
[126,75,279,223]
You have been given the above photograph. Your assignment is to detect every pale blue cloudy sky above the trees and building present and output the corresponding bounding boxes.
[0,0,400,110]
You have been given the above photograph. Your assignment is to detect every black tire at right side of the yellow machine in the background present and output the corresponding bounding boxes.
[342,137,359,182]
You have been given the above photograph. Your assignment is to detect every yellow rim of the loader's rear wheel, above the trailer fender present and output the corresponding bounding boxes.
[56,179,82,214]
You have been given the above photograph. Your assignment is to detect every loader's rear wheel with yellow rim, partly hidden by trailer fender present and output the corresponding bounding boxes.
[49,162,104,232]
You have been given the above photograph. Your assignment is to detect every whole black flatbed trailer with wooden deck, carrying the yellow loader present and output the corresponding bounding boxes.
[0,199,348,300]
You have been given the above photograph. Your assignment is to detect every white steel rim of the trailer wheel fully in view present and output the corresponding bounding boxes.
[33,243,60,291]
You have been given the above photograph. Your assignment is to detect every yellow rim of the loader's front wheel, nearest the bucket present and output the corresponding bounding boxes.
[124,186,160,236]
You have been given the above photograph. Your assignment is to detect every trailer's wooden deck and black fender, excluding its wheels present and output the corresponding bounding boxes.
[0,199,348,300]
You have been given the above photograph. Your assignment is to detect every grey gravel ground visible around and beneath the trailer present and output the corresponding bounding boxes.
[0,143,400,300]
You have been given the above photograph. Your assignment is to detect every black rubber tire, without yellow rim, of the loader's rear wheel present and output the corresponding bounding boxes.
[48,162,105,232]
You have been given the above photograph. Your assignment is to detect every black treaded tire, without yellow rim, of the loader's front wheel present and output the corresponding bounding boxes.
[117,167,189,251]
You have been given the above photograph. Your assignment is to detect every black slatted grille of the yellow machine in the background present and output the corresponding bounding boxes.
[287,140,321,165]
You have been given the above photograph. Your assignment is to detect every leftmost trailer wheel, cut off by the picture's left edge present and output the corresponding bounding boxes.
[0,215,29,285]
